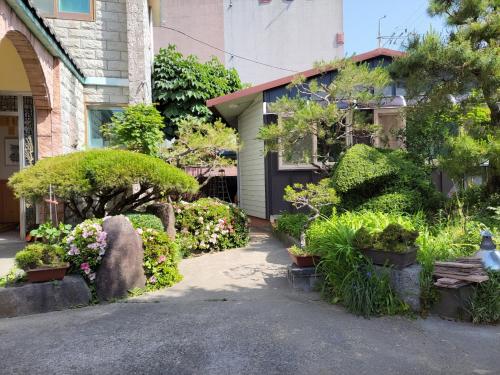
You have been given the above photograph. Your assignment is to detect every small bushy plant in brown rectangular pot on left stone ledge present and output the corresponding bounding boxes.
[16,243,69,283]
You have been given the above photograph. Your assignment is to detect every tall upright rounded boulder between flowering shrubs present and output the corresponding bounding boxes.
[95,215,146,301]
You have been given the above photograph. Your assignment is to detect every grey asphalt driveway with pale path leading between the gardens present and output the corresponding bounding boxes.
[0,229,500,375]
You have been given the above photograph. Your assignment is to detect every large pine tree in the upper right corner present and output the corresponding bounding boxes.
[391,0,500,127]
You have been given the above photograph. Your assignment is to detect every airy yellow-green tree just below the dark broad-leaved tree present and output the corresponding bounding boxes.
[161,117,239,187]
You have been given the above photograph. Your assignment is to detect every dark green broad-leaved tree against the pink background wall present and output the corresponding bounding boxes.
[153,45,242,136]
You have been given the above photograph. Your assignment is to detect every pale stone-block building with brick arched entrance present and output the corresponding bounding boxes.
[0,0,153,238]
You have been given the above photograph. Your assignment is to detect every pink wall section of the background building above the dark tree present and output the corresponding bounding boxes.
[154,0,224,62]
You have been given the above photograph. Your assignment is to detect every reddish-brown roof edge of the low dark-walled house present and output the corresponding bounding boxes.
[206,48,404,108]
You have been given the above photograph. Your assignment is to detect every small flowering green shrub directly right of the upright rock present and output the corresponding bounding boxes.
[139,228,182,290]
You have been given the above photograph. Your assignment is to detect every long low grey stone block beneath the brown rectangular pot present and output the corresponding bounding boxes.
[0,276,91,318]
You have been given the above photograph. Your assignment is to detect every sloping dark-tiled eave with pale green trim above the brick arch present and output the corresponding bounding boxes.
[6,0,85,84]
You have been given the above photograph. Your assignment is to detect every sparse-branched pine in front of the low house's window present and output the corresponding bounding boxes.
[259,59,390,170]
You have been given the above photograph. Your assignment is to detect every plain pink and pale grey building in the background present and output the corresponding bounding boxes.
[151,0,344,85]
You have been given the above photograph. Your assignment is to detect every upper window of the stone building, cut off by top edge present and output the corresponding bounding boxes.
[32,0,95,21]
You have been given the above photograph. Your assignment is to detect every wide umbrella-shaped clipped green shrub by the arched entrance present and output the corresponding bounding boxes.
[9,149,198,220]
